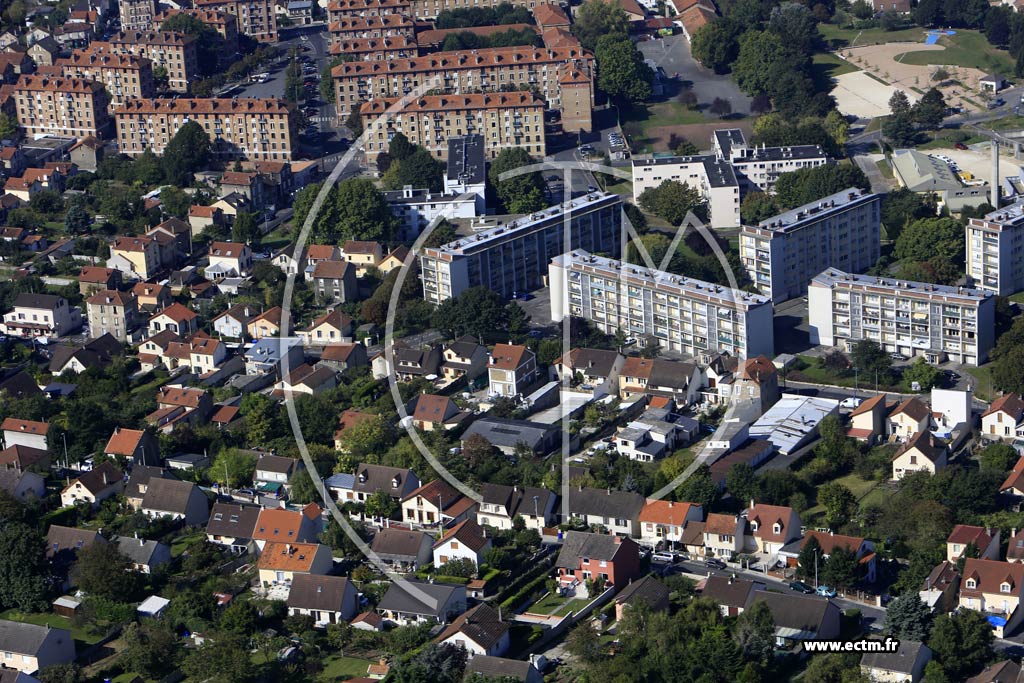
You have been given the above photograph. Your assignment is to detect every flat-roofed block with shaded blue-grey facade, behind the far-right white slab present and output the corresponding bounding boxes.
[739,187,882,303]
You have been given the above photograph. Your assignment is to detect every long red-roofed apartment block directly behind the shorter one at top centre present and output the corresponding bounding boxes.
[331,47,594,118]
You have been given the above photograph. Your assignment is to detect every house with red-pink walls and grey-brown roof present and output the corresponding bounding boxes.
[555,530,640,597]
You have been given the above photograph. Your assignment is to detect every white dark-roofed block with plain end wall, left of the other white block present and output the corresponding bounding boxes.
[633,155,740,228]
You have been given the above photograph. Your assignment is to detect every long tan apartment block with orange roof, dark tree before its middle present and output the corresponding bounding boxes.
[114,97,295,162]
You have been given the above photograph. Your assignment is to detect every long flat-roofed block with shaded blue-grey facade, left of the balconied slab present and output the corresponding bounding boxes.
[420,193,623,303]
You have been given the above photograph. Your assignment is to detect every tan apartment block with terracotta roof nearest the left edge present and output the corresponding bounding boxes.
[12,75,111,138]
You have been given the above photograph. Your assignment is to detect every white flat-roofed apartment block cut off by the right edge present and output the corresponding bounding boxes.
[967,201,1024,296]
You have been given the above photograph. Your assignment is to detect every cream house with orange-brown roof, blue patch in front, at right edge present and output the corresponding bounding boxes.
[959,557,1024,638]
